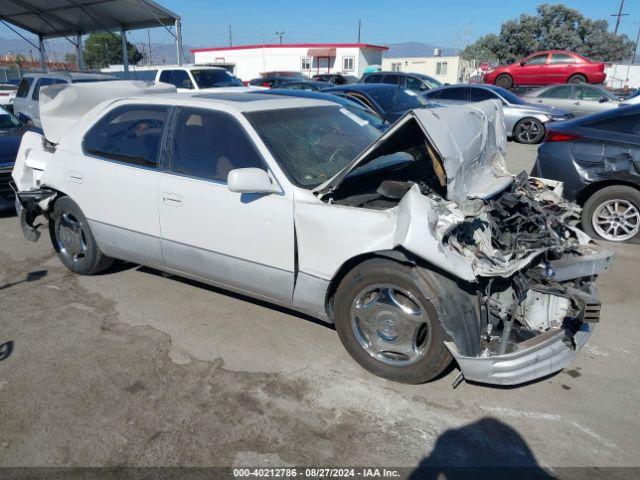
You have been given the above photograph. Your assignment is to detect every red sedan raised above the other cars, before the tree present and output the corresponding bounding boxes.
[483,50,607,88]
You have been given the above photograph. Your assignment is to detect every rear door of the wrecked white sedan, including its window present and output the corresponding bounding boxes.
[70,104,169,267]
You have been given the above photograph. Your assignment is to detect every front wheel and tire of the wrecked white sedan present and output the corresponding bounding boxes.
[334,259,456,384]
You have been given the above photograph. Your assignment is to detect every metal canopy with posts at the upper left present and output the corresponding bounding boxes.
[0,0,184,77]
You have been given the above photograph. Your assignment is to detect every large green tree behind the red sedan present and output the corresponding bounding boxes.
[462,4,634,63]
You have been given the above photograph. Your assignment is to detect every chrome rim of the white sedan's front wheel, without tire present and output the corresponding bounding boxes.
[351,284,431,366]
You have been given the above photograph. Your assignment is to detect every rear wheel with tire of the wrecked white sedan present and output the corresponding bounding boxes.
[49,197,113,275]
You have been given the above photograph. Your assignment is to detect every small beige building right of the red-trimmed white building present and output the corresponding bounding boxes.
[382,57,472,83]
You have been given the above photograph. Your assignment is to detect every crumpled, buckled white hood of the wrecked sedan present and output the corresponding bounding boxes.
[314,100,513,204]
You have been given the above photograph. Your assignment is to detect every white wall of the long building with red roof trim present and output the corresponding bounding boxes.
[194,45,382,81]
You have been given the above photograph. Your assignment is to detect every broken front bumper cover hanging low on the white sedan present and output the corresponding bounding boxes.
[445,323,594,385]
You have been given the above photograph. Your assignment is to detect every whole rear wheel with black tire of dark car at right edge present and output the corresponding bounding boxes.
[582,185,640,242]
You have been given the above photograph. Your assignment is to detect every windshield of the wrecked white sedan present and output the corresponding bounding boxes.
[245,106,380,189]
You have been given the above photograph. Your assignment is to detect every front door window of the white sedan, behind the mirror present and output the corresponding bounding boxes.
[171,108,265,182]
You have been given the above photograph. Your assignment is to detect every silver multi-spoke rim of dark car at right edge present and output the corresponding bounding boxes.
[591,198,640,242]
